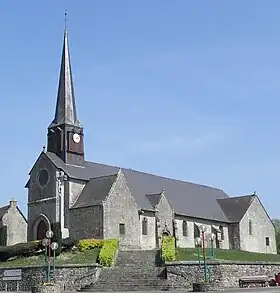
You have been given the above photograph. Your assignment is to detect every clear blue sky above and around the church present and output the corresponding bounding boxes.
[0,0,280,217]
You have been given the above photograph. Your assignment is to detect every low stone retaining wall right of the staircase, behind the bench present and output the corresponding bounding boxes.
[166,261,280,288]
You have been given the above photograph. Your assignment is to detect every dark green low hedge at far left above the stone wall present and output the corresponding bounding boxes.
[0,241,43,261]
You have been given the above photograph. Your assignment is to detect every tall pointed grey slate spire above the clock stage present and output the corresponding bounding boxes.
[50,19,81,127]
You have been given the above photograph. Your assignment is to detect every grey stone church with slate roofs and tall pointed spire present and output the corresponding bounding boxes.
[26,30,276,253]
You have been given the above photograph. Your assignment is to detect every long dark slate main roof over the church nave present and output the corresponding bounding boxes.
[45,152,228,222]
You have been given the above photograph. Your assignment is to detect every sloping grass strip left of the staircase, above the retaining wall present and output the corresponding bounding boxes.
[0,248,100,267]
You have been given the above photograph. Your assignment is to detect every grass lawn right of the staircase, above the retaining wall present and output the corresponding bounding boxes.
[176,248,280,262]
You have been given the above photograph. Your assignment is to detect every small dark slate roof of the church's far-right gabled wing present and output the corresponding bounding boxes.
[217,194,256,223]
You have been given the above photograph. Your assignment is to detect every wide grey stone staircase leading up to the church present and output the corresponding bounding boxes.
[80,250,167,292]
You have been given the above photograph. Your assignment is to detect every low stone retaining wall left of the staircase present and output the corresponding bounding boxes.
[0,264,102,291]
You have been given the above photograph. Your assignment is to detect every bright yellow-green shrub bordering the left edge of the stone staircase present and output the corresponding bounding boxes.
[99,239,119,267]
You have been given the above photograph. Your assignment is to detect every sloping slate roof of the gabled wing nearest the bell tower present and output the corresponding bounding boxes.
[72,174,118,209]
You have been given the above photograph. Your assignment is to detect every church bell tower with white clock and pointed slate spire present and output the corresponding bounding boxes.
[47,22,84,165]
